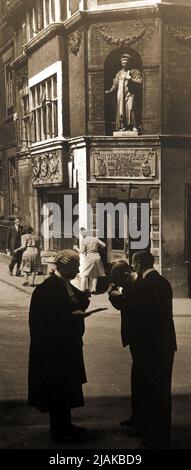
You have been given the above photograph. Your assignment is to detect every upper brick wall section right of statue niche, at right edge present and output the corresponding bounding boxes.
[161,21,191,134]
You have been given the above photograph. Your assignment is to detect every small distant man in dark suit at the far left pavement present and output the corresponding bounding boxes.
[7,217,23,276]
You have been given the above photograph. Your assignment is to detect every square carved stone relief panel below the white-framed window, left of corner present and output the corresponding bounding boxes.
[32,150,63,186]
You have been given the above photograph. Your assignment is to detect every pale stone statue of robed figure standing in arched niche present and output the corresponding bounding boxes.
[105,54,143,131]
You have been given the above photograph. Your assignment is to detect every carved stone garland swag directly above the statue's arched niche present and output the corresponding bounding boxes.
[99,22,154,47]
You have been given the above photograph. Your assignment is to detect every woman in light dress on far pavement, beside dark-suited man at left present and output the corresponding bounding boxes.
[14,225,41,287]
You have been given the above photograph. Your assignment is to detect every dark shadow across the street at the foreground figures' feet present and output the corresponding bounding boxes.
[0,394,191,449]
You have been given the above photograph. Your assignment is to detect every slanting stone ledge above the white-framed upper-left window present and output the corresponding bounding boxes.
[23,23,65,55]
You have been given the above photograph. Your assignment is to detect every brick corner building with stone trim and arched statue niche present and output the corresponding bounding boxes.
[0,0,191,296]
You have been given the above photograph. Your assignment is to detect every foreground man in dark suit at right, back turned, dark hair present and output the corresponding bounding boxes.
[111,251,177,449]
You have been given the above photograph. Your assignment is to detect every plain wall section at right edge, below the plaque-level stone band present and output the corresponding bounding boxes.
[161,148,191,296]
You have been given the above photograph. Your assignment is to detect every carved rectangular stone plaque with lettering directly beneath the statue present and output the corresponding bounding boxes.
[92,148,157,180]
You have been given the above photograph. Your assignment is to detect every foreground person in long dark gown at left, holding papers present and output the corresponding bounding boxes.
[28,250,89,440]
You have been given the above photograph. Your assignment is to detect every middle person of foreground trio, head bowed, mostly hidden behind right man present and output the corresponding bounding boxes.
[108,260,140,436]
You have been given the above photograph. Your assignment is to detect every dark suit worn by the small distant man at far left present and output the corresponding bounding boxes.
[7,225,23,274]
